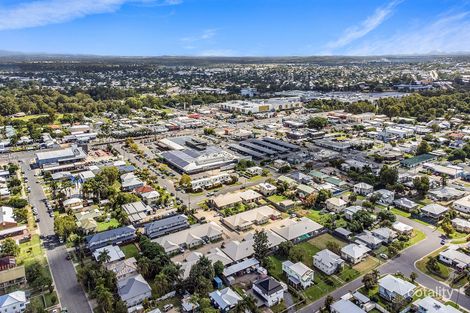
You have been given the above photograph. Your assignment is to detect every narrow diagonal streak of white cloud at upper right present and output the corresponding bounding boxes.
[327,0,401,49]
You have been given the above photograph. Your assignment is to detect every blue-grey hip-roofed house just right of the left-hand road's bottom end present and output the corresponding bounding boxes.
[117,274,152,308]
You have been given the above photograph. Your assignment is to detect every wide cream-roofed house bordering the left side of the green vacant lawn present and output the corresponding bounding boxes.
[272,217,324,243]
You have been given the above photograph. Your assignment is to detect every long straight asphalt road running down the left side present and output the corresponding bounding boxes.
[17,152,92,313]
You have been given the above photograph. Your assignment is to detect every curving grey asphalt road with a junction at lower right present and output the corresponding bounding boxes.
[298,216,470,313]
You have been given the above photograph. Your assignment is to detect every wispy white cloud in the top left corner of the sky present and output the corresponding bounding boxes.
[0,0,181,30]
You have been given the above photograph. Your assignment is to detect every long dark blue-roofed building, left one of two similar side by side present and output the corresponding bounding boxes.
[85,225,136,251]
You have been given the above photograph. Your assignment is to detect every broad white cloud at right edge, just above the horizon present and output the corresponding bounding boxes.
[346,11,470,55]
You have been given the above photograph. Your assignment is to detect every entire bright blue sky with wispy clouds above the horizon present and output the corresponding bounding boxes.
[0,0,470,56]
